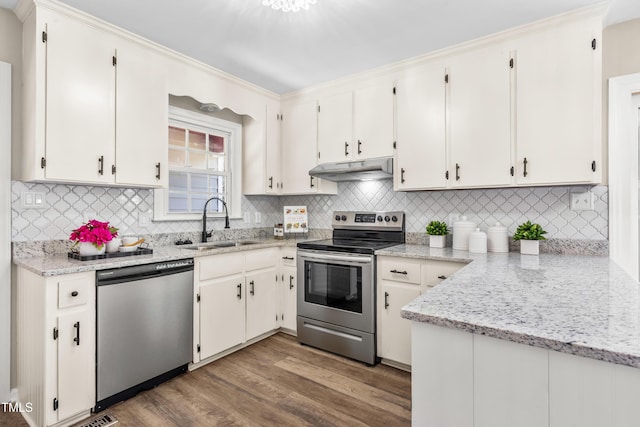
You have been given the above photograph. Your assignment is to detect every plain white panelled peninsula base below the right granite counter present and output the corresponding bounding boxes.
[411,322,640,427]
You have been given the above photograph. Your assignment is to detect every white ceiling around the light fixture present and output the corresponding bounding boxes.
[0,0,640,93]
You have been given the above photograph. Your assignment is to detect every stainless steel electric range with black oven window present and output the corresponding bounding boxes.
[297,212,405,365]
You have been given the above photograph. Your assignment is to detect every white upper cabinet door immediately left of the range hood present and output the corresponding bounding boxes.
[282,101,318,194]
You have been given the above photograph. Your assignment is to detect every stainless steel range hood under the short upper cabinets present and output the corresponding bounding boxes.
[309,157,393,181]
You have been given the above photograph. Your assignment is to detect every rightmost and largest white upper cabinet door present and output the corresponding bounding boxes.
[516,18,602,185]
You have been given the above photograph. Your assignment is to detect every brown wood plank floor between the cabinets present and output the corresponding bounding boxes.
[1,334,411,427]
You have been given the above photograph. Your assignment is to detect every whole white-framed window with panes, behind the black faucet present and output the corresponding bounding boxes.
[154,107,242,220]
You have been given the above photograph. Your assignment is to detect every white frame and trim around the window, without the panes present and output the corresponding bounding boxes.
[153,105,242,221]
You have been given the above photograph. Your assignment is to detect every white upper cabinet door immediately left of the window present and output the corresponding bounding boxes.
[114,40,169,187]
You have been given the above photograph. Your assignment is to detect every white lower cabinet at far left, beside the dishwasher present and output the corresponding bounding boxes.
[16,267,96,426]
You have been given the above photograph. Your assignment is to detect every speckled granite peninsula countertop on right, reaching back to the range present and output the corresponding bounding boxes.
[376,245,640,368]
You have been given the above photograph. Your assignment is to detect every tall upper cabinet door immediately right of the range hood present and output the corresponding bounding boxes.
[394,64,447,190]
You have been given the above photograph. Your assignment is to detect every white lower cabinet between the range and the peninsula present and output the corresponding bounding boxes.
[377,256,465,369]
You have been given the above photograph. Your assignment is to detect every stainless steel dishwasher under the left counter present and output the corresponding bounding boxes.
[94,259,193,412]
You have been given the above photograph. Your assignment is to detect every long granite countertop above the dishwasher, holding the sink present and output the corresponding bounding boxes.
[13,238,297,276]
